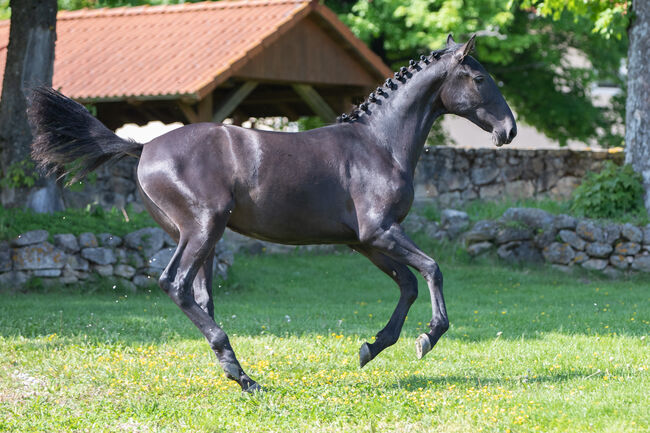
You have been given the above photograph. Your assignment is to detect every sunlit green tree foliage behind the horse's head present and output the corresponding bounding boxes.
[326,0,627,146]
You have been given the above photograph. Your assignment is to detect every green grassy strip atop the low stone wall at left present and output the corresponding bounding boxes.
[0,202,156,240]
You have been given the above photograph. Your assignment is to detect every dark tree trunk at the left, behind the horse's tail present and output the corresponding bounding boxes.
[0,0,63,212]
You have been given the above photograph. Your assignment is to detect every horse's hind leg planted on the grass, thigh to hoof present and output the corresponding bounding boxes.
[160,215,260,392]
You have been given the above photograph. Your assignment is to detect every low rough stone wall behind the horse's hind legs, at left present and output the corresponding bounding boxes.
[0,228,233,289]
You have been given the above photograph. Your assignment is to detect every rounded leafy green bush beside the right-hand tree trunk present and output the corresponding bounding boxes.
[571,161,645,218]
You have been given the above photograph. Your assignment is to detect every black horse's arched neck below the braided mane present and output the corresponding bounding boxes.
[367,61,446,175]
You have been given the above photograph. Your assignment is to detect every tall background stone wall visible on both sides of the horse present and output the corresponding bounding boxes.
[64,146,624,211]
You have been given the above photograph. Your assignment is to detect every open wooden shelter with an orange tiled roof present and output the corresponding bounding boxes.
[0,0,391,129]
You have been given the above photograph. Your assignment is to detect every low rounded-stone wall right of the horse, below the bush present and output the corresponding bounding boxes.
[404,208,650,277]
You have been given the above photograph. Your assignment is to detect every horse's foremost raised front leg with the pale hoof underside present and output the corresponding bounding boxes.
[367,223,449,358]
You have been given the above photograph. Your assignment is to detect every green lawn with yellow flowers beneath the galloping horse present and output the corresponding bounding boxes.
[0,251,650,432]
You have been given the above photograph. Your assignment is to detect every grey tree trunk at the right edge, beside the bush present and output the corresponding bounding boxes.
[625,0,650,215]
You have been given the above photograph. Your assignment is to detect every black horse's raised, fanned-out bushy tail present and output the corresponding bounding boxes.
[27,87,142,183]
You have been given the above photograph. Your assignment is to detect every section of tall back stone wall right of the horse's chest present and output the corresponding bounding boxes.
[415,146,624,206]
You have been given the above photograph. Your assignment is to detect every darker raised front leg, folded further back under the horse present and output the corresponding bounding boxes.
[351,245,418,367]
